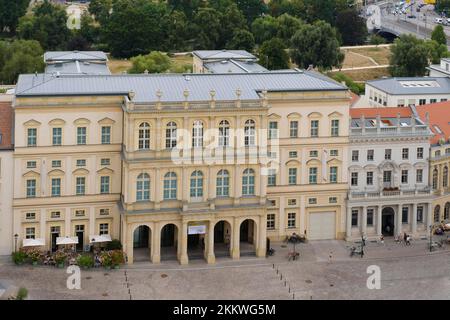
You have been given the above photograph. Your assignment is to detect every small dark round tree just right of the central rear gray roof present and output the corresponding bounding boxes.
[259,38,289,70]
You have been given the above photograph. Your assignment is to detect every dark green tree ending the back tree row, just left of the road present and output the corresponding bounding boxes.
[336,9,368,46]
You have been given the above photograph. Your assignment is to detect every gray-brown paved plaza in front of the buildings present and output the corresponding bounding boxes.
[0,240,450,300]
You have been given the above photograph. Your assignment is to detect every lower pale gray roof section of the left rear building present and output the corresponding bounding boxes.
[45,60,111,75]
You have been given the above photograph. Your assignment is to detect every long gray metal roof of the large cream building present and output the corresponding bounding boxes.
[16,70,347,103]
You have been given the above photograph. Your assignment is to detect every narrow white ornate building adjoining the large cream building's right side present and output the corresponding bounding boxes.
[346,108,433,239]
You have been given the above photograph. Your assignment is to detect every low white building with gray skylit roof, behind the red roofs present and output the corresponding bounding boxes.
[354,77,450,108]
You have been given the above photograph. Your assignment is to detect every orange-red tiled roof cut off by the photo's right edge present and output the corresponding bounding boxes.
[416,101,450,144]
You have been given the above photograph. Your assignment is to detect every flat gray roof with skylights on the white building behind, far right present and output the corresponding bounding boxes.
[367,77,450,95]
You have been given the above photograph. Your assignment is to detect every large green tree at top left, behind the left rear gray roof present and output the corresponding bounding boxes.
[18,0,70,50]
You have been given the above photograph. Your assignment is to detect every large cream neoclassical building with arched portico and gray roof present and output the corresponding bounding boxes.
[13,70,349,264]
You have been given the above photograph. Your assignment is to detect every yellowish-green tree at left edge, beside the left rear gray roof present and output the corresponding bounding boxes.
[0,40,44,84]
